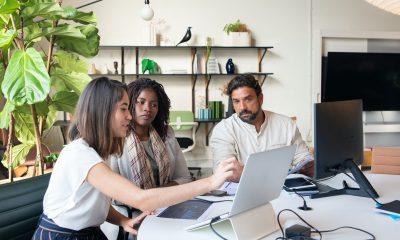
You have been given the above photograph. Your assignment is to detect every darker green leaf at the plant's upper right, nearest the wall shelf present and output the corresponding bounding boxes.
[56,25,100,58]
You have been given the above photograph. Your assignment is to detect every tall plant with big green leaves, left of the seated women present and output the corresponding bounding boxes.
[0,0,100,178]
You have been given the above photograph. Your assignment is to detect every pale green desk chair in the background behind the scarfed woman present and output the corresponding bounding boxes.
[169,111,201,180]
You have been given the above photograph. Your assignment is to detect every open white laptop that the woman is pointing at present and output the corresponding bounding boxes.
[185,145,296,231]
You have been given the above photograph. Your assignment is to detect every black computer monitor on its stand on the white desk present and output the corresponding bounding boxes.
[311,100,378,198]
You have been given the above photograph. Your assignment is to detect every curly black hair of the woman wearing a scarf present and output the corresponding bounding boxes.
[128,78,171,141]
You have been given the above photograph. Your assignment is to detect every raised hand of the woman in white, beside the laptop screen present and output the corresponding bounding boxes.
[210,157,237,191]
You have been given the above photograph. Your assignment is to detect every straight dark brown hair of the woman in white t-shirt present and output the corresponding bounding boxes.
[68,77,127,159]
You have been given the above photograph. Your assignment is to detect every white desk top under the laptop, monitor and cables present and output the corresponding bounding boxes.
[138,174,400,240]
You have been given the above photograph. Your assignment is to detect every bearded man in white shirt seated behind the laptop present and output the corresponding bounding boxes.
[210,75,314,182]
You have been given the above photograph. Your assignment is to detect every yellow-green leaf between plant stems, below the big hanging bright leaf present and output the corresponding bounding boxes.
[13,111,35,143]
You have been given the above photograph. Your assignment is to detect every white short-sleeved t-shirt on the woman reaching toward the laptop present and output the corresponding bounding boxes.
[43,139,111,230]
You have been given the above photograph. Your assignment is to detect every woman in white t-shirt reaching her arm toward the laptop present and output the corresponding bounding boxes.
[32,77,236,239]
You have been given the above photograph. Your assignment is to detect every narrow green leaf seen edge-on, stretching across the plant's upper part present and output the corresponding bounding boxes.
[25,24,86,41]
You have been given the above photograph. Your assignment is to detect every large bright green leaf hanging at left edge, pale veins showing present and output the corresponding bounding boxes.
[1,48,50,106]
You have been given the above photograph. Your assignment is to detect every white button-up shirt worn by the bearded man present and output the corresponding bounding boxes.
[210,111,312,168]
